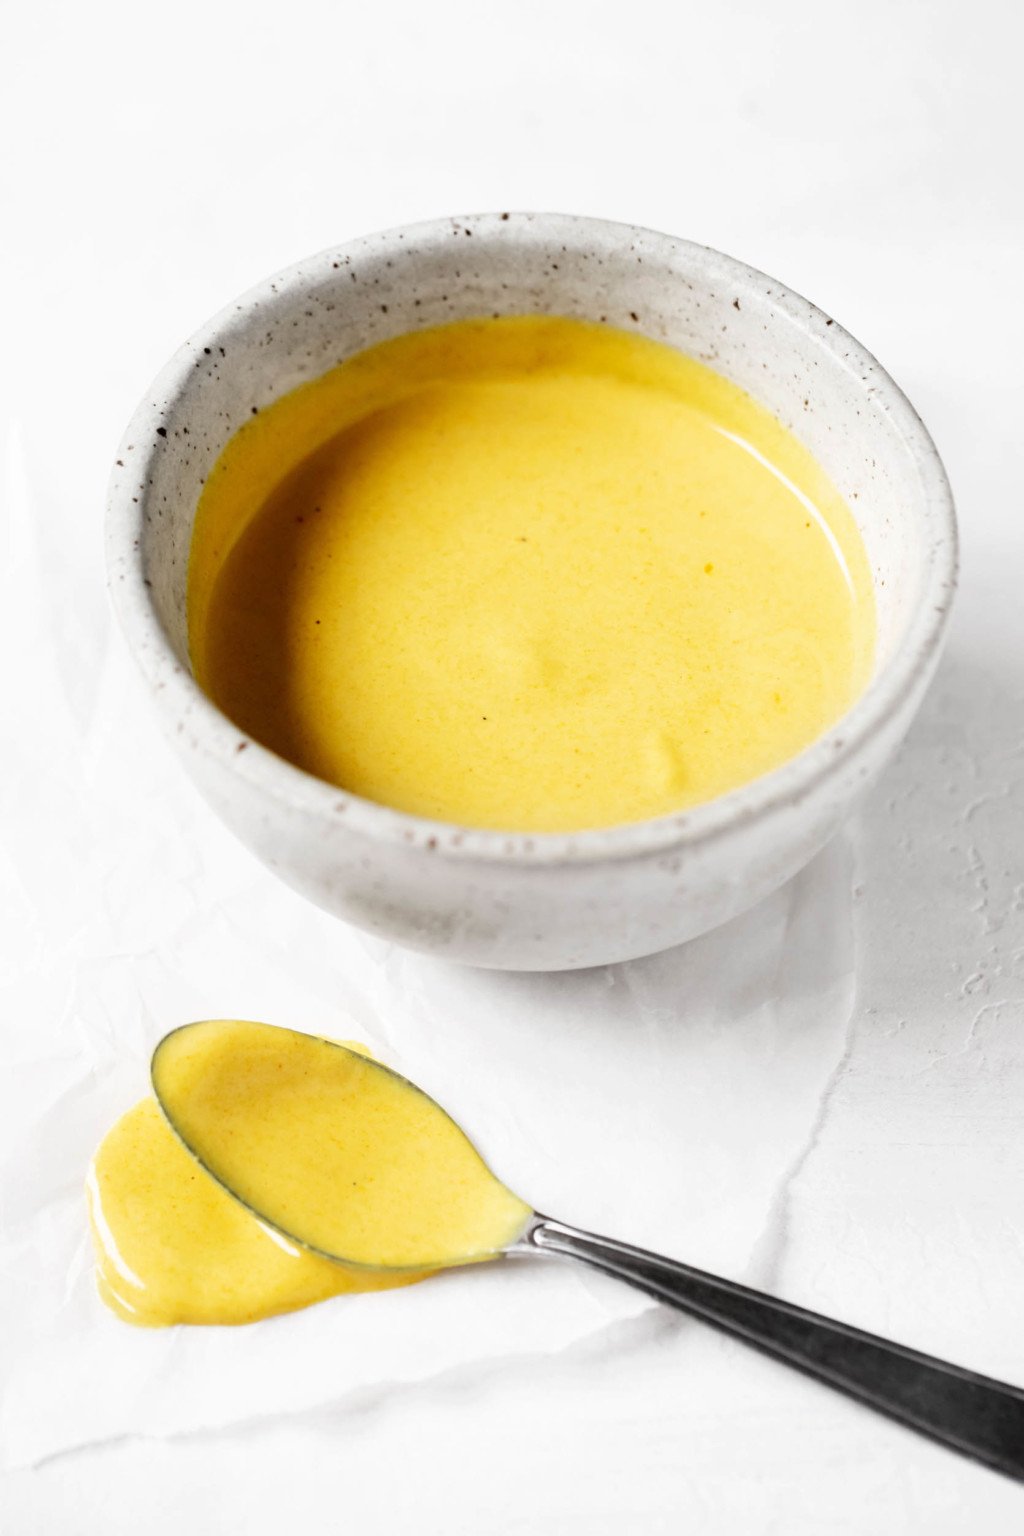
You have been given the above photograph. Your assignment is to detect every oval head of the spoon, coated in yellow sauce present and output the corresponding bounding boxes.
[150,1018,531,1272]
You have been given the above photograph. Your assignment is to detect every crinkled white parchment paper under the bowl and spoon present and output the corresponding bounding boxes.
[0,439,852,1464]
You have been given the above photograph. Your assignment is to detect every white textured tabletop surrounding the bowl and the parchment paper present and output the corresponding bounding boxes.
[0,0,1024,1536]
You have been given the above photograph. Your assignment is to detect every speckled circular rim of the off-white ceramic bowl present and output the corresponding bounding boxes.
[106,212,958,866]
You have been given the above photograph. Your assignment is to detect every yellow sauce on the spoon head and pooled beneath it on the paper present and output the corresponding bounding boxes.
[88,1020,530,1327]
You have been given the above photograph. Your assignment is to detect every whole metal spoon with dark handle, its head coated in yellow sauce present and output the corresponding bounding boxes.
[152,1021,1024,1481]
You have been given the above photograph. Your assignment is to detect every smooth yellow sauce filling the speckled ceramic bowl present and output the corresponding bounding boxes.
[189,316,874,831]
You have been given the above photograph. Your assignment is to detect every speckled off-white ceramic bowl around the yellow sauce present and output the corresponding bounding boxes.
[107,214,956,969]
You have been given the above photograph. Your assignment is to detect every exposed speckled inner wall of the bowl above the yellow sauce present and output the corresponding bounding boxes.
[126,214,941,721]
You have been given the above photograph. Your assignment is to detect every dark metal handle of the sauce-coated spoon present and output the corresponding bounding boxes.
[514,1217,1024,1481]
